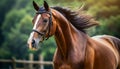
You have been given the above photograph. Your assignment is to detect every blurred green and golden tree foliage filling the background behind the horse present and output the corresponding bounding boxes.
[0,0,120,69]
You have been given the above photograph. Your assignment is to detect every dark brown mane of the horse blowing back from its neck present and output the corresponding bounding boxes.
[52,6,98,32]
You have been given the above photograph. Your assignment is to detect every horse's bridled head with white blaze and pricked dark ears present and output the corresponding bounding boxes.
[28,1,55,49]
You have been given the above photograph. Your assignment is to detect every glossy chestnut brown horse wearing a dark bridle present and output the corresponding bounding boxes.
[27,1,120,69]
